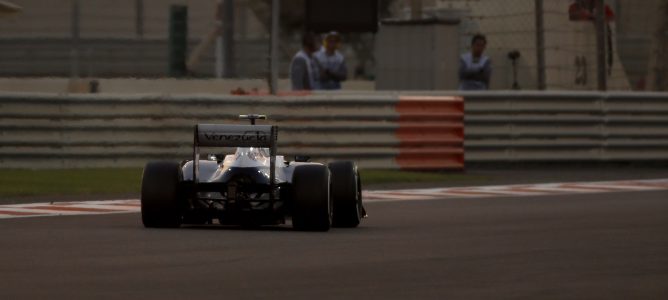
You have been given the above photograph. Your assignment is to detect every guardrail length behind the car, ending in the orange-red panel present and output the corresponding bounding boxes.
[0,94,464,169]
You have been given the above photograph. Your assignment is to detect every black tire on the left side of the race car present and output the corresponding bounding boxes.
[141,161,185,228]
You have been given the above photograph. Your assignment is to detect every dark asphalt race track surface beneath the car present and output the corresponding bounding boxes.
[0,190,668,299]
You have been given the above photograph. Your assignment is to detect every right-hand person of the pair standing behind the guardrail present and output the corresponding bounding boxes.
[313,31,348,90]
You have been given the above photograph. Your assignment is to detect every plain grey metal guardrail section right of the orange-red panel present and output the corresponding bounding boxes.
[465,92,668,162]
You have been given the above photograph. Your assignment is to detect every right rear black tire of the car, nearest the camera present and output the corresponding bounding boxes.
[292,164,332,231]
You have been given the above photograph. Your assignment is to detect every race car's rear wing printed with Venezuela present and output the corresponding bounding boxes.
[193,124,278,188]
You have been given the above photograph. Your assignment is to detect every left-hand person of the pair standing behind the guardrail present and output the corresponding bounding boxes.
[290,33,317,91]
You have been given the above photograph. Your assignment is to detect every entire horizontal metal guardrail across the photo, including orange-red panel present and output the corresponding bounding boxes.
[0,92,668,169]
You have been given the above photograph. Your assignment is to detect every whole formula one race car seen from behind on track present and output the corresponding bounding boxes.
[141,115,366,231]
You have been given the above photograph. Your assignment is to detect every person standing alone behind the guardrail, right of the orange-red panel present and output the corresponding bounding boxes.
[459,34,492,90]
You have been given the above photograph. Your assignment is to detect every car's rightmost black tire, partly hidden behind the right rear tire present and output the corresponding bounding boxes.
[329,161,363,228]
